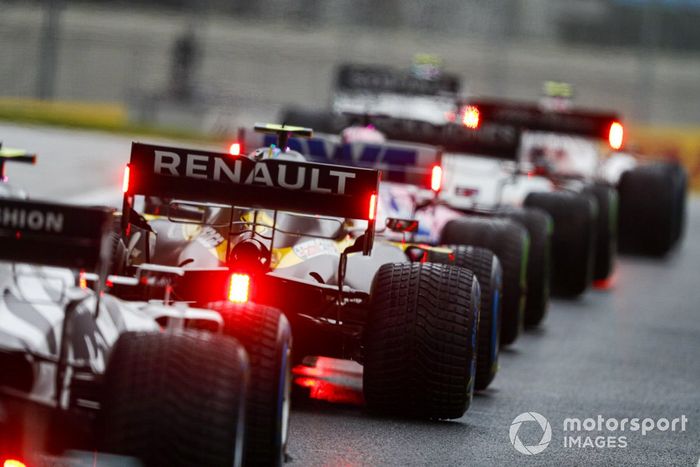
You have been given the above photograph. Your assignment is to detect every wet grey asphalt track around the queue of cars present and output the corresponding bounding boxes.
[0,124,700,467]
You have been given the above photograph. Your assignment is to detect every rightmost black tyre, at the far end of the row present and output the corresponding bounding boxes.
[618,163,687,256]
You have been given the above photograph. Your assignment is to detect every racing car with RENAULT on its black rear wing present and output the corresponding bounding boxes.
[115,125,480,419]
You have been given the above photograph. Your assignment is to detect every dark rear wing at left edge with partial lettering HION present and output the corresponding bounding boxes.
[0,199,113,273]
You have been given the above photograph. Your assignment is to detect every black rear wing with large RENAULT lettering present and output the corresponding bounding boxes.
[123,143,379,220]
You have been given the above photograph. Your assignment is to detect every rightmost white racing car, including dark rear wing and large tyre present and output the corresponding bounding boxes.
[468,87,688,260]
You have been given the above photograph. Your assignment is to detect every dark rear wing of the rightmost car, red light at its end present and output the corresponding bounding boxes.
[464,98,623,149]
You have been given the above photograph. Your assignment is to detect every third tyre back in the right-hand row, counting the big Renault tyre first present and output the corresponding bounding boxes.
[440,216,530,345]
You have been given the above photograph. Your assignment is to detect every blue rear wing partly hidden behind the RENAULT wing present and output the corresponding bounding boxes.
[238,128,442,191]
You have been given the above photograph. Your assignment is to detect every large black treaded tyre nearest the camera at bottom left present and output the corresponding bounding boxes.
[99,332,248,466]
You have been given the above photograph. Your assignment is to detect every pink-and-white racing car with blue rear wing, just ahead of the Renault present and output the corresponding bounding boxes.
[234,128,500,390]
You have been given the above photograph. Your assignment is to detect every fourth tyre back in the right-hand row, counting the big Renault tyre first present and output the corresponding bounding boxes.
[500,207,554,326]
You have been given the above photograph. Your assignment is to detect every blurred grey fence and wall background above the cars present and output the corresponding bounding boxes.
[0,0,700,183]
